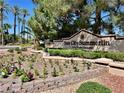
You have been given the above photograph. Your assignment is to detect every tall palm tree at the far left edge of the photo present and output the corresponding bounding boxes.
[0,0,9,45]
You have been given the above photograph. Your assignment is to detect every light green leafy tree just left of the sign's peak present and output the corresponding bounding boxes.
[28,0,71,48]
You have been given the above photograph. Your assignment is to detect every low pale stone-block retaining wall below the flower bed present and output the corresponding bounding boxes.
[0,66,109,93]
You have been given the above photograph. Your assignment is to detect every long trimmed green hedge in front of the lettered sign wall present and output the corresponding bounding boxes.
[48,49,124,61]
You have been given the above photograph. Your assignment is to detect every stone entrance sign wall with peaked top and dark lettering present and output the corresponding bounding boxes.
[53,29,124,51]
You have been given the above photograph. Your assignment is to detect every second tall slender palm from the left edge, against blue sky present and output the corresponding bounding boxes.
[12,6,20,43]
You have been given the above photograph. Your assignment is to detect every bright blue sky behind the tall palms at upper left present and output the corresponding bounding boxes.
[4,0,35,33]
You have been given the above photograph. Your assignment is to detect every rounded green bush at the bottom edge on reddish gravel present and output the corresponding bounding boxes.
[76,82,112,93]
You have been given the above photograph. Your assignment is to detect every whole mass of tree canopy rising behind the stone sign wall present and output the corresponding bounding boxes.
[28,0,124,43]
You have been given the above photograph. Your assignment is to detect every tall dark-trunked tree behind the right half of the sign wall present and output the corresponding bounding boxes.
[59,0,124,34]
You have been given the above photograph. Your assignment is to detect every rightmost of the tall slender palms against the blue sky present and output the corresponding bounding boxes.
[21,9,29,43]
